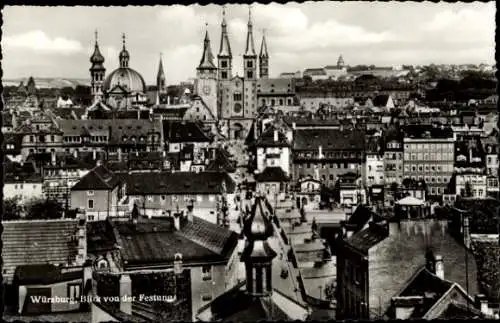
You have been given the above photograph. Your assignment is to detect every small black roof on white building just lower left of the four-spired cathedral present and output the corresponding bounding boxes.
[163,120,211,142]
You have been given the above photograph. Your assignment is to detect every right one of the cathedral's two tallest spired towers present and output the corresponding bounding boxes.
[243,8,257,118]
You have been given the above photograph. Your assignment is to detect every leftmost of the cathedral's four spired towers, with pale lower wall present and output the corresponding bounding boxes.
[195,24,218,118]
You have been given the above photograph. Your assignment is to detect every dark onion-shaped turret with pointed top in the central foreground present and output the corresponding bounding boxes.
[241,196,277,297]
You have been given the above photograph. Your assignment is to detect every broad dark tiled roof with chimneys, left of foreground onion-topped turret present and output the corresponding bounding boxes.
[113,217,238,266]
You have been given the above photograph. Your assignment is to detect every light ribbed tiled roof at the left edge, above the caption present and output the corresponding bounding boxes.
[2,220,78,279]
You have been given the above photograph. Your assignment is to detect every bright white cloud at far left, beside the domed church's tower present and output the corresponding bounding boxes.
[3,30,83,54]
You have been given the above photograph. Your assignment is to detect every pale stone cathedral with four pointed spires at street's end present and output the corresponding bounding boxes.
[194,8,269,139]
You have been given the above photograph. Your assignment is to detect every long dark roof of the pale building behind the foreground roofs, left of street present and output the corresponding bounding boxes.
[127,172,236,195]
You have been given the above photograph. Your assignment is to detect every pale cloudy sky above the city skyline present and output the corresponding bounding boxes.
[2,2,496,84]
